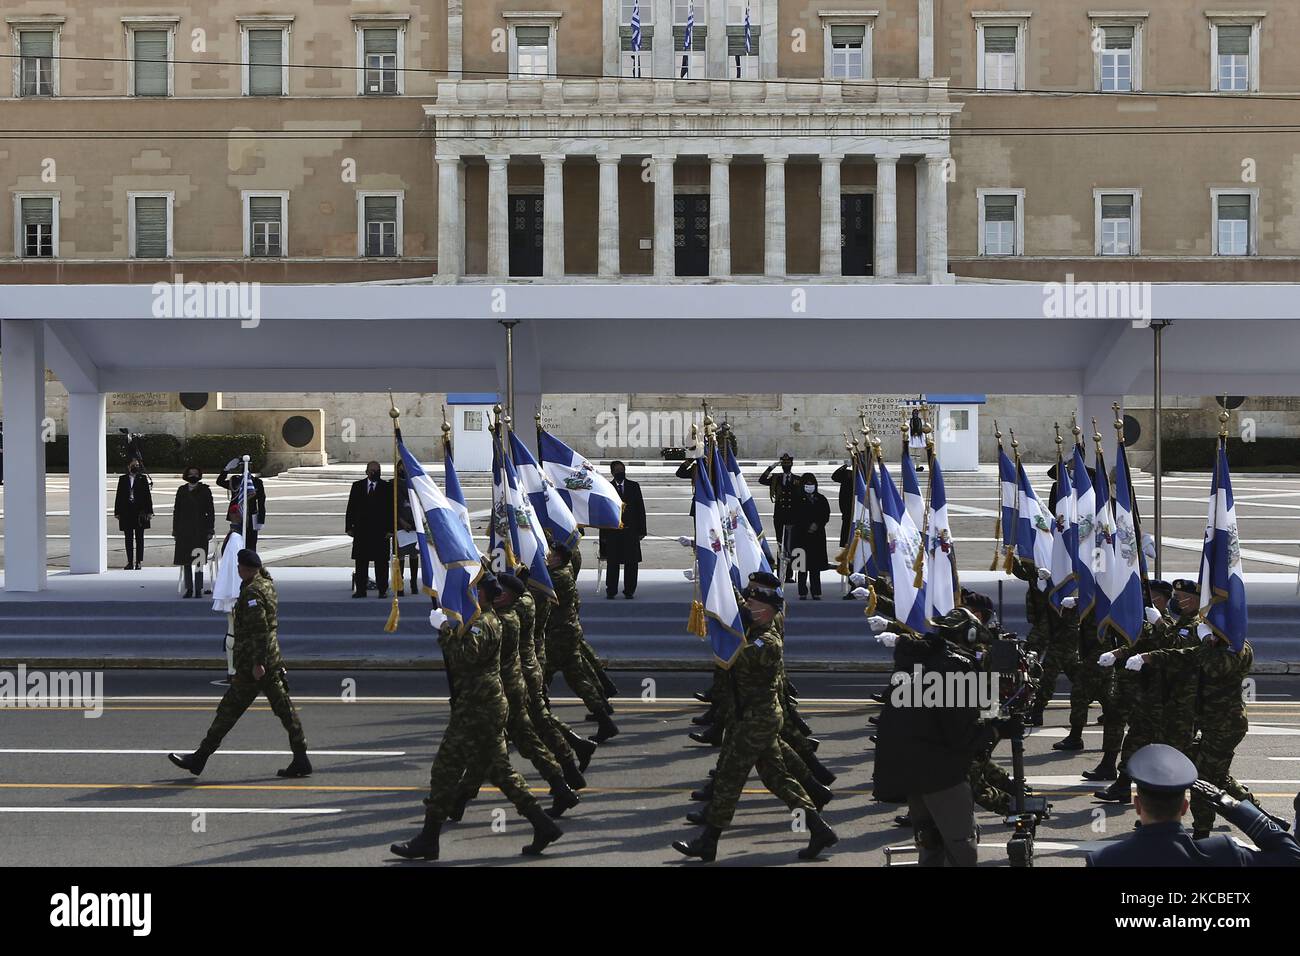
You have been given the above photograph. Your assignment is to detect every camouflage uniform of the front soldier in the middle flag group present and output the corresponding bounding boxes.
[705,620,815,829]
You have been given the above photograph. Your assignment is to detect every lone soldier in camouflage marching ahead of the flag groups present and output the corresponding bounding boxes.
[168,548,312,777]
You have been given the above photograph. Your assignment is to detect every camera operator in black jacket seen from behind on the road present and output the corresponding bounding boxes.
[875,632,997,866]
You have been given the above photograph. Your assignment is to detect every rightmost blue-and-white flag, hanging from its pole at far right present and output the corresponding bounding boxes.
[1200,441,1249,652]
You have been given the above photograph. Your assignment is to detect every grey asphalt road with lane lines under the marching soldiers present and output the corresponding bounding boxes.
[0,671,1300,866]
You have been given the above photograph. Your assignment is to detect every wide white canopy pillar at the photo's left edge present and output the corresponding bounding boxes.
[0,319,47,592]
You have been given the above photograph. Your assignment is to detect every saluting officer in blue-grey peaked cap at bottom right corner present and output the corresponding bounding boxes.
[1088,744,1300,866]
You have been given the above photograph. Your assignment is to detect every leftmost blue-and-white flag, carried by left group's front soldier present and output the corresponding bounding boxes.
[398,440,482,626]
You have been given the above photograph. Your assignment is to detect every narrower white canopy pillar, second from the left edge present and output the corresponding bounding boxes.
[68,392,108,575]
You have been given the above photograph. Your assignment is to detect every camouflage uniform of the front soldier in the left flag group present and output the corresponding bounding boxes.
[424,610,540,821]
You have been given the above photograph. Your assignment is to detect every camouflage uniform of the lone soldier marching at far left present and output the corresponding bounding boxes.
[199,570,307,754]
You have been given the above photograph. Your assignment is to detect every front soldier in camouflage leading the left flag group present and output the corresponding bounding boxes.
[390,572,563,860]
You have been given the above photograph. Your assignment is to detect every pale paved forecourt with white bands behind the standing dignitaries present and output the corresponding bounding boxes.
[0,466,1300,574]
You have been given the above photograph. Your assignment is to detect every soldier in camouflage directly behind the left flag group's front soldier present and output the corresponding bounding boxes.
[449,574,586,821]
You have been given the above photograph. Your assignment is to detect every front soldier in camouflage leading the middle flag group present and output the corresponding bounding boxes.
[672,584,839,862]
